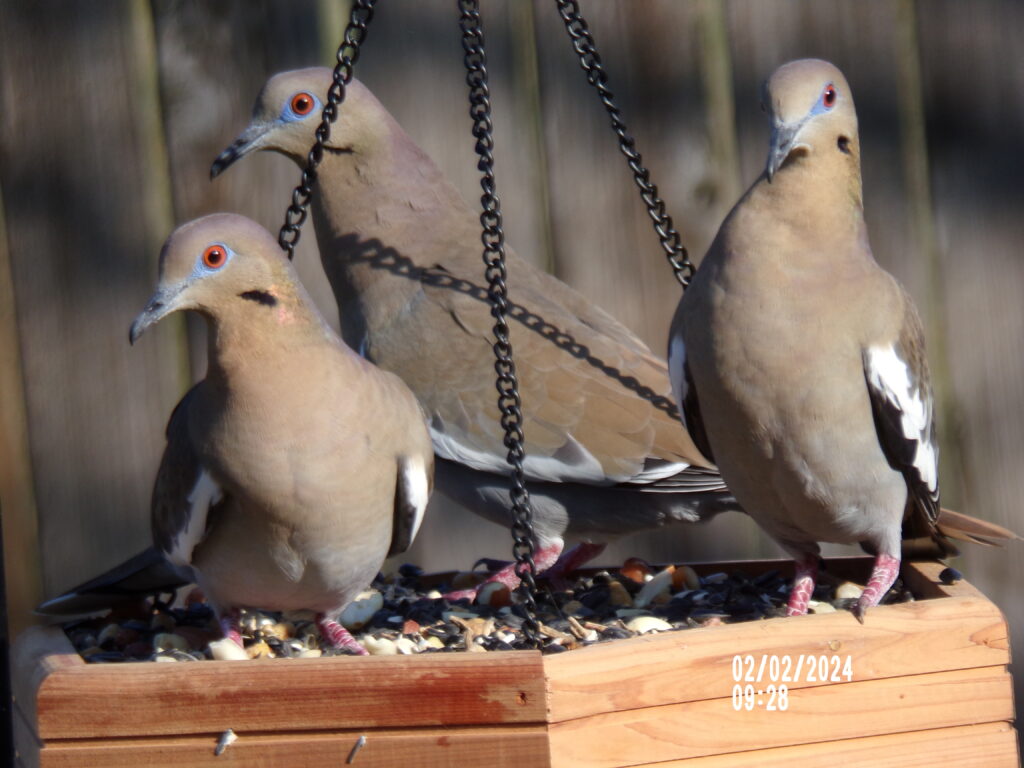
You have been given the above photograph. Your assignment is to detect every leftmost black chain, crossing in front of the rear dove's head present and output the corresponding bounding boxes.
[278,0,377,260]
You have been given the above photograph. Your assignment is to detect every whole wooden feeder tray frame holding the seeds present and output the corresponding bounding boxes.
[13,558,1019,768]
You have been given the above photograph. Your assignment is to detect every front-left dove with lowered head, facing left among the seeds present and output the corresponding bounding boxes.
[117,214,433,652]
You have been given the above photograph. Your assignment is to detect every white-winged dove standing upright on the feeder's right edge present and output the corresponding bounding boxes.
[669,59,1016,620]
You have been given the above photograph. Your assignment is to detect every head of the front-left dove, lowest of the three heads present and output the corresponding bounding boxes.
[129,213,294,344]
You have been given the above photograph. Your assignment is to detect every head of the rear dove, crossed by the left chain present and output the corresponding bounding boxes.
[210,67,384,178]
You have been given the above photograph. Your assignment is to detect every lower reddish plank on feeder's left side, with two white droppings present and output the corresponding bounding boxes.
[34,725,550,768]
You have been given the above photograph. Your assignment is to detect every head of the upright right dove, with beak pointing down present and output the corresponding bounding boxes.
[763,58,859,181]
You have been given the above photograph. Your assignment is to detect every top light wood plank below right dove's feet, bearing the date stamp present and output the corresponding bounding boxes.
[544,585,1010,723]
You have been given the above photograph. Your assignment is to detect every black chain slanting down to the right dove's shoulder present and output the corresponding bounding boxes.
[555,0,696,290]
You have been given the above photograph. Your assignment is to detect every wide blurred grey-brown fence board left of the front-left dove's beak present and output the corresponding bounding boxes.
[0,2,181,594]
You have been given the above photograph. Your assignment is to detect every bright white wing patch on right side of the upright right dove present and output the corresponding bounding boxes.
[866,346,939,495]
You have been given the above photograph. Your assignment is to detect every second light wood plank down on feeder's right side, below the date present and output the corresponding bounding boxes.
[549,667,1014,768]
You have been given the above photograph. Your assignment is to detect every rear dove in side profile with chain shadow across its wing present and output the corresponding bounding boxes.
[211,68,734,598]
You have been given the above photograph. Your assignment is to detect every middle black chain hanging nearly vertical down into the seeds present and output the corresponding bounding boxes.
[459,0,543,647]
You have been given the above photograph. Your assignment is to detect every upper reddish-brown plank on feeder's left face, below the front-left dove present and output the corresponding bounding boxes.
[36,651,546,741]
